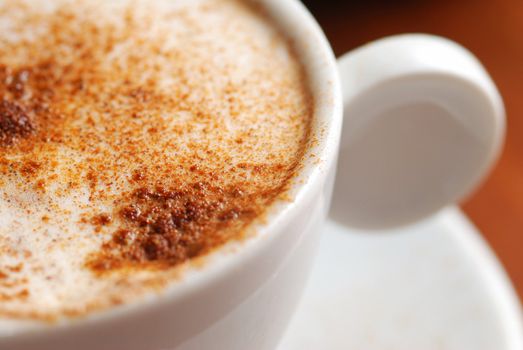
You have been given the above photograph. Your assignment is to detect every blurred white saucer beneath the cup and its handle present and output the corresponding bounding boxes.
[278,208,523,350]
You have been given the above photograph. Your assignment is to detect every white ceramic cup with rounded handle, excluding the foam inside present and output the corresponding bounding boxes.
[0,0,504,350]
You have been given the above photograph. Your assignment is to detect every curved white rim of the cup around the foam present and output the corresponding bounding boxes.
[0,0,342,347]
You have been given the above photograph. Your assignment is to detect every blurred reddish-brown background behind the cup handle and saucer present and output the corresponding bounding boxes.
[304,0,523,299]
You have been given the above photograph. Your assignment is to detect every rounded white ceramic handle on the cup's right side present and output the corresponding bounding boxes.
[331,34,505,229]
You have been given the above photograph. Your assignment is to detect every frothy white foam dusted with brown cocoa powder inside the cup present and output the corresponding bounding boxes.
[0,0,312,320]
